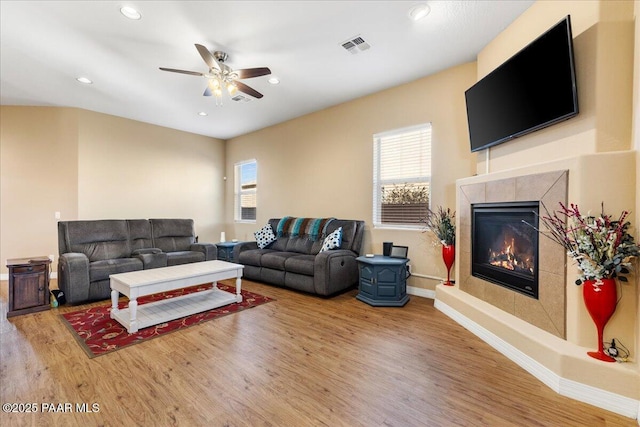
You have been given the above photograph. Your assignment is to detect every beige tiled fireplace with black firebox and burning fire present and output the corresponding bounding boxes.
[458,170,568,338]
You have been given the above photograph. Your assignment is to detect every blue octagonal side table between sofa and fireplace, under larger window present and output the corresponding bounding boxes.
[356,255,409,307]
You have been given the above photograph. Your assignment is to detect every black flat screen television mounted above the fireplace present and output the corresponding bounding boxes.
[465,16,578,152]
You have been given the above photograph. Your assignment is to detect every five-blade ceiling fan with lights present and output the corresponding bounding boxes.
[160,43,271,103]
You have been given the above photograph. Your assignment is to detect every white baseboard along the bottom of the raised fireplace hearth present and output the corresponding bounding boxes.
[434,300,640,425]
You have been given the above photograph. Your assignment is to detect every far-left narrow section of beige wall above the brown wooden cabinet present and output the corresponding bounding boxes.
[0,106,78,273]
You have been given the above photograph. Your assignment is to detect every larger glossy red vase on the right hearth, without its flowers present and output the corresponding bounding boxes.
[582,279,618,362]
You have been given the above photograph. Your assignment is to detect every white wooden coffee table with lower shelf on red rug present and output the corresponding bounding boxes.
[109,260,244,334]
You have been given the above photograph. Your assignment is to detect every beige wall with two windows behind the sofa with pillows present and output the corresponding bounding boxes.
[226,63,476,289]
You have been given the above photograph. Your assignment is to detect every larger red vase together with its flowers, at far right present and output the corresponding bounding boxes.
[539,203,640,362]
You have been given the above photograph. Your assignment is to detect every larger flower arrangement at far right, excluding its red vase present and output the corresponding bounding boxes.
[539,203,640,285]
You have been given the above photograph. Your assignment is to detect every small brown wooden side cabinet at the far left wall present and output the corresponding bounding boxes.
[7,257,51,317]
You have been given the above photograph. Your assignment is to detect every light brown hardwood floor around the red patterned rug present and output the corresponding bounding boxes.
[0,281,637,427]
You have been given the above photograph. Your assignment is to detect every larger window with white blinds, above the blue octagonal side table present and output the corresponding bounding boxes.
[373,123,431,228]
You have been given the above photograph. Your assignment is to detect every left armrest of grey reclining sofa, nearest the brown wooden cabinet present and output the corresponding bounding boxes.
[58,252,89,304]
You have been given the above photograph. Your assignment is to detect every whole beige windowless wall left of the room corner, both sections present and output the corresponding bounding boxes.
[0,107,225,273]
